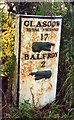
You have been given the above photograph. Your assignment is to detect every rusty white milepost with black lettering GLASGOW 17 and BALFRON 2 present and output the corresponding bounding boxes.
[15,15,62,108]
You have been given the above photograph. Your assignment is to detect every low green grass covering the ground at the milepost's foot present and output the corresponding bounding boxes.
[6,101,74,120]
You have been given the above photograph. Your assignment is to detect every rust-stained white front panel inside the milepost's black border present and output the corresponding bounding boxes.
[17,17,60,107]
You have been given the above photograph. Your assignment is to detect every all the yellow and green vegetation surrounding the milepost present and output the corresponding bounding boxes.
[0,2,74,120]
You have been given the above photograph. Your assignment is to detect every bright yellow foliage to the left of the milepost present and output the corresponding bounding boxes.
[2,13,15,58]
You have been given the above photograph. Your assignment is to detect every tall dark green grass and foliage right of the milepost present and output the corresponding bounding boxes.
[60,4,74,108]
